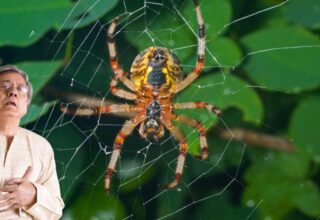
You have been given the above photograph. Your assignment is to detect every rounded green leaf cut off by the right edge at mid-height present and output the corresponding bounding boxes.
[289,98,320,163]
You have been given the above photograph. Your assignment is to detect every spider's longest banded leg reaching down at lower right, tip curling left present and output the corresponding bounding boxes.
[161,119,188,189]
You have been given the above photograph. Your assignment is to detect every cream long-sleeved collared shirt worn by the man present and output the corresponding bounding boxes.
[0,127,64,220]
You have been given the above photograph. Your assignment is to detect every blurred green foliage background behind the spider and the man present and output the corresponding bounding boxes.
[0,0,320,220]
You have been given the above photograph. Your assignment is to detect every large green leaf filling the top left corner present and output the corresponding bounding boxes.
[0,0,71,46]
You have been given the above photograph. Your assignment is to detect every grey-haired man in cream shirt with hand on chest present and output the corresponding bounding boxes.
[0,65,64,220]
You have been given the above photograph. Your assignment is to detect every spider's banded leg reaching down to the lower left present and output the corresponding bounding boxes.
[104,116,142,192]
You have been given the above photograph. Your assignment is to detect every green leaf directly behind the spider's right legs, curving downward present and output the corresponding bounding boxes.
[175,72,263,124]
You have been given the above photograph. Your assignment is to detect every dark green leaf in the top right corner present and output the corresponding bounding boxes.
[284,0,320,29]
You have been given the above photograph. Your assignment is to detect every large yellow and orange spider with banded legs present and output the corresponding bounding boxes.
[61,0,222,192]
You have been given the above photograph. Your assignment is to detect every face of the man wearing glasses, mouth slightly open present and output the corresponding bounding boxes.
[0,72,28,120]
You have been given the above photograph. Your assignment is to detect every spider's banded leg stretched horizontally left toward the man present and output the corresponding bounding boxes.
[60,103,135,116]
